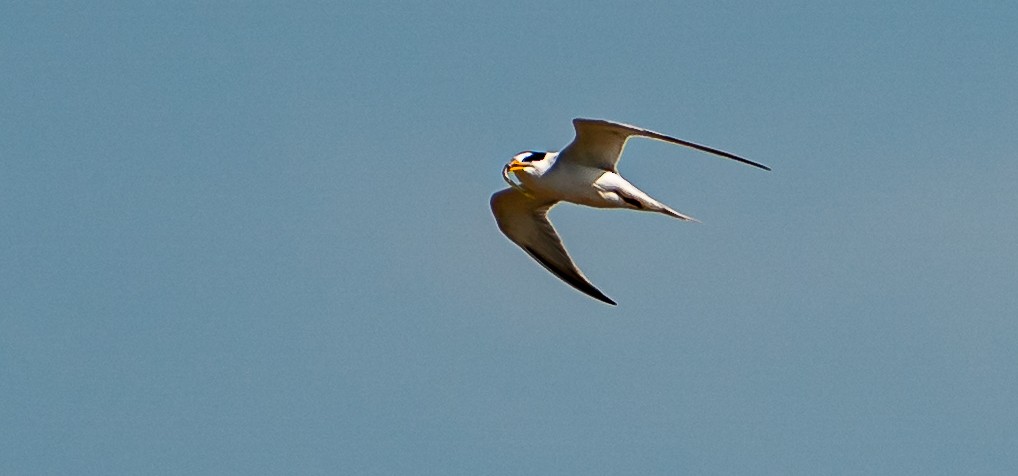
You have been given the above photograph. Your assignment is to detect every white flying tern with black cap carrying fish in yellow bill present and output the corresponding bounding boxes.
[491,119,771,305]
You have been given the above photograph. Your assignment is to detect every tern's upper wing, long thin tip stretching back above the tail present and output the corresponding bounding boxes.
[559,118,771,172]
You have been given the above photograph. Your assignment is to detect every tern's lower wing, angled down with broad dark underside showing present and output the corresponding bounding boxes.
[492,188,615,305]
